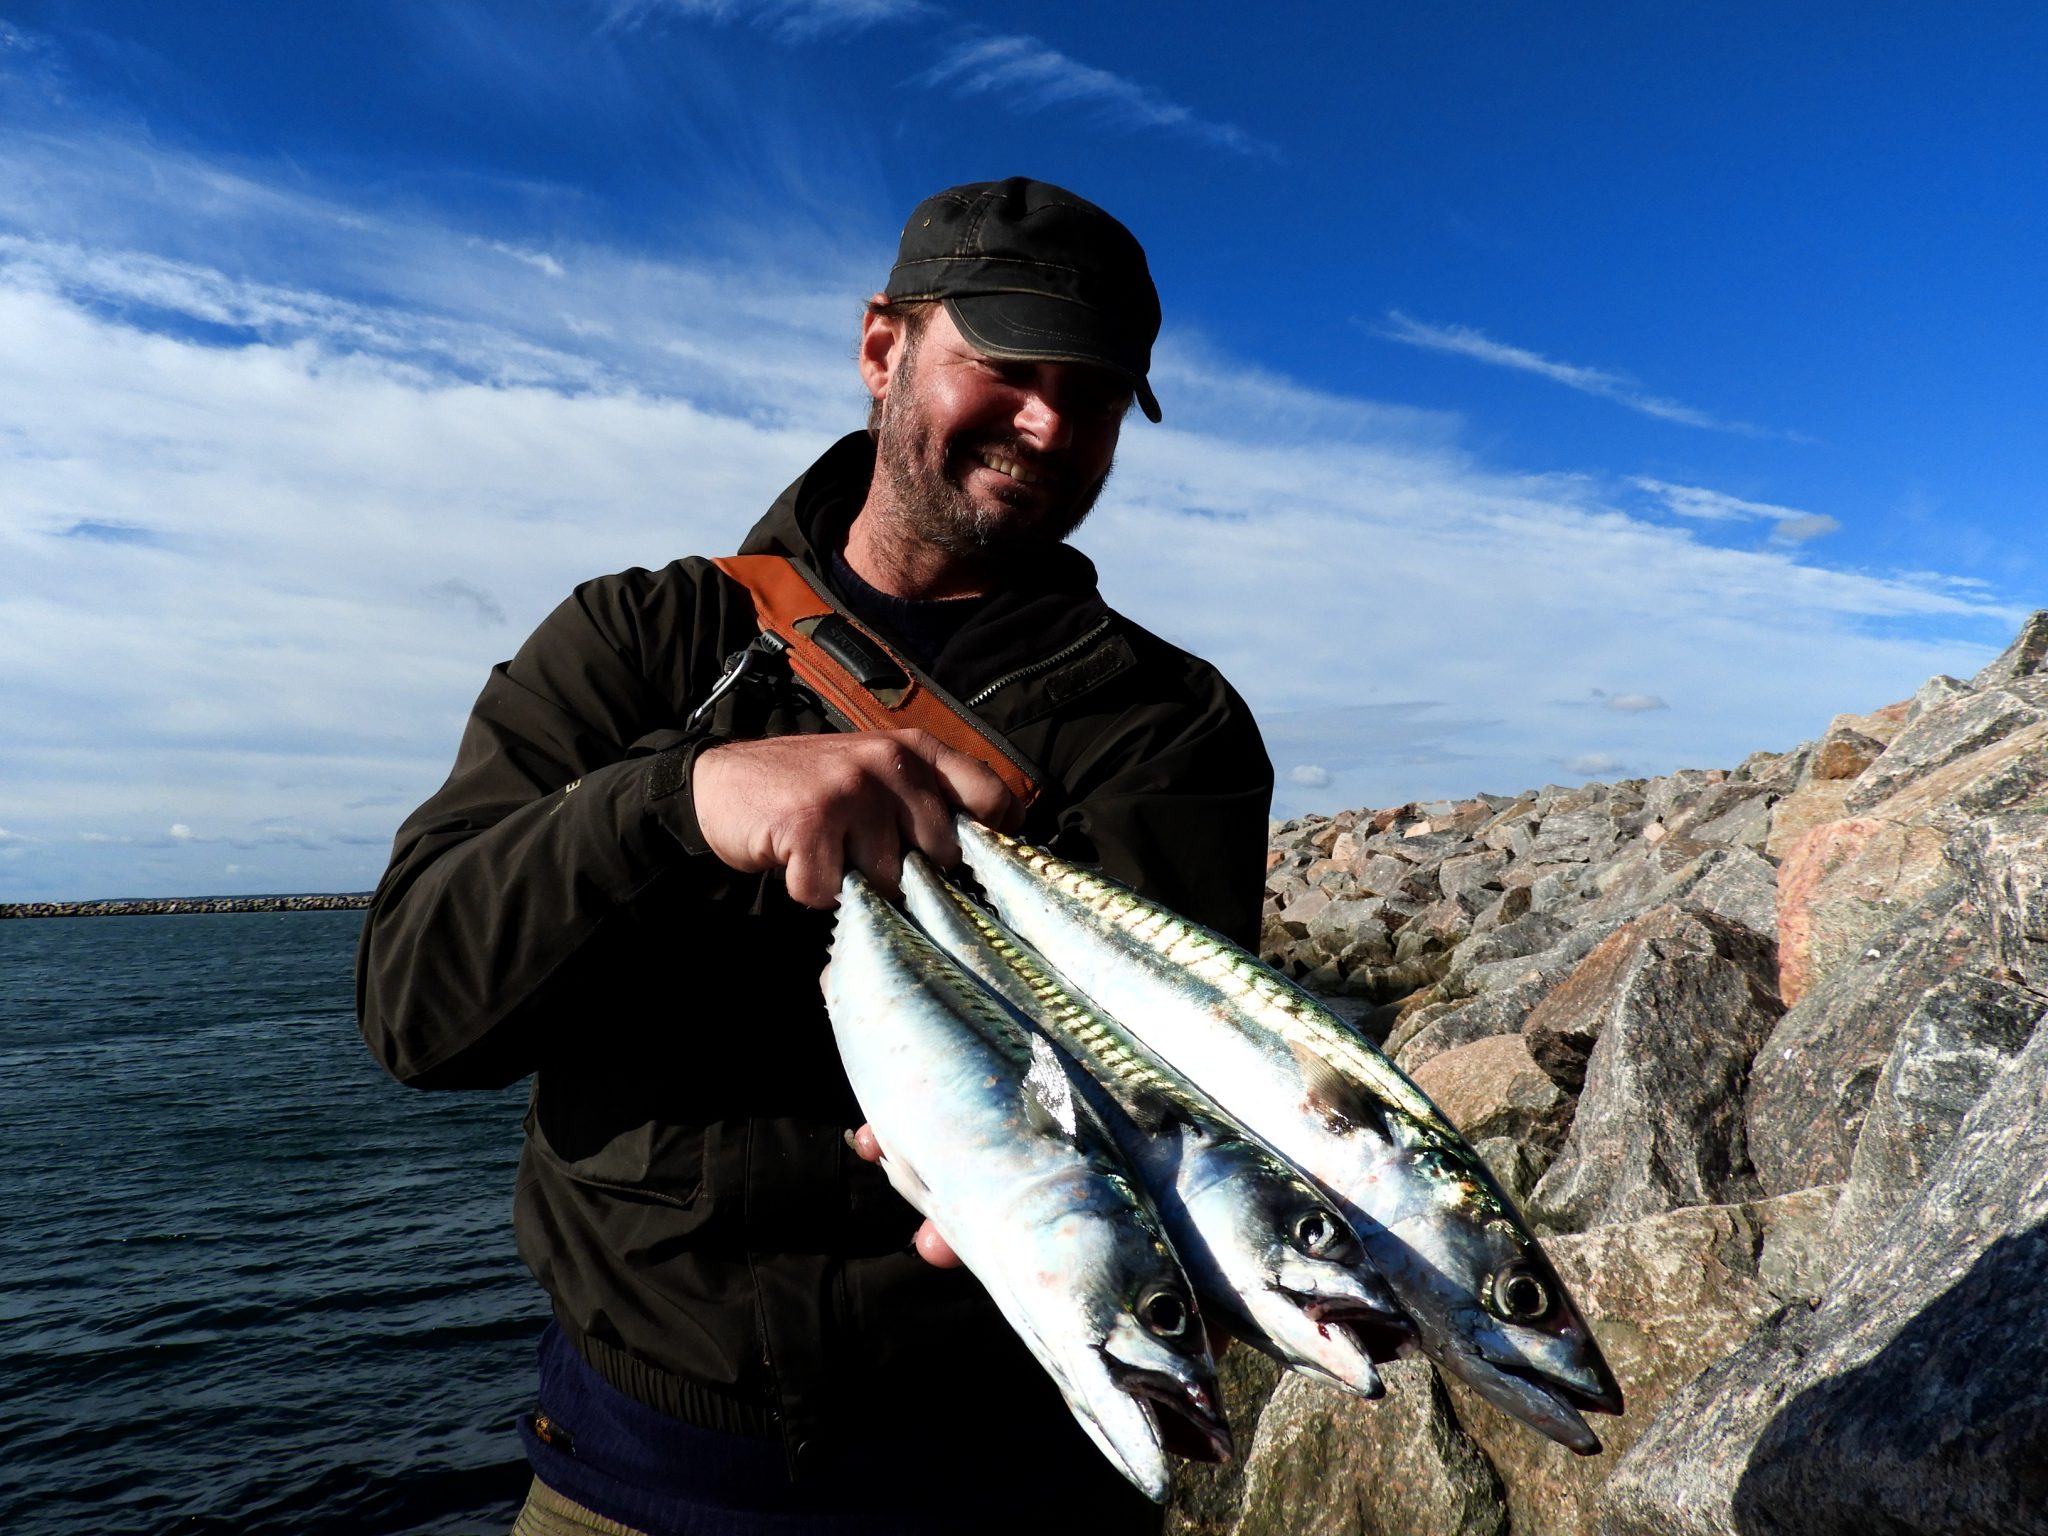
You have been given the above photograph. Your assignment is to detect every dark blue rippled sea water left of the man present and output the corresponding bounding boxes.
[0,911,545,1536]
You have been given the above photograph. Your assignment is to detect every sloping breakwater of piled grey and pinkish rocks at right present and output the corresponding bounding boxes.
[1167,612,2048,1536]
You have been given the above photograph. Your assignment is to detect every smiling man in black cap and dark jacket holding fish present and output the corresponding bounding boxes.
[356,178,1272,1532]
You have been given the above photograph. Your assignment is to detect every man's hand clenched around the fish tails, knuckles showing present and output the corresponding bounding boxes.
[690,729,1022,907]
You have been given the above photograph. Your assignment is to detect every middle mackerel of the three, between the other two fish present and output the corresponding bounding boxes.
[903,854,1409,1397]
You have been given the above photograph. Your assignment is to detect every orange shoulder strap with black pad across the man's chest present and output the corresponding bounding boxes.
[711,555,1038,805]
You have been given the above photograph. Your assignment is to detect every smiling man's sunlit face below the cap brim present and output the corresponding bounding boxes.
[860,305,1130,561]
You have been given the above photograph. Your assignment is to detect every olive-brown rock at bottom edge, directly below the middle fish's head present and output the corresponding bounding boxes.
[1235,1360,1507,1536]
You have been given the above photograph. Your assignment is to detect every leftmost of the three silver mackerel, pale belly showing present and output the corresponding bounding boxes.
[823,872,1231,1501]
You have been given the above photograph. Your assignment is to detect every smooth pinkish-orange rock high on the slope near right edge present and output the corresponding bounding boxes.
[1778,817,1950,1006]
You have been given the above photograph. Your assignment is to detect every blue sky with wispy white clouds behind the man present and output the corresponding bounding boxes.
[0,0,2048,901]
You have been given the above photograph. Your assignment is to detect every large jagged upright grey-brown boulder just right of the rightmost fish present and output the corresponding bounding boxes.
[1524,907,1780,1231]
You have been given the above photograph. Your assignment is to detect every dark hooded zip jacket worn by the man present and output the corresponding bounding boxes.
[356,434,1272,1464]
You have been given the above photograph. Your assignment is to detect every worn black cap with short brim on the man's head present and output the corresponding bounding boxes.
[885,176,1159,422]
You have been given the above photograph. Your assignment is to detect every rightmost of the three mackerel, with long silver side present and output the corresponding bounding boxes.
[956,817,1622,1454]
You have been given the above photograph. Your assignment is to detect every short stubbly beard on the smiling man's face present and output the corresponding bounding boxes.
[874,344,1110,567]
